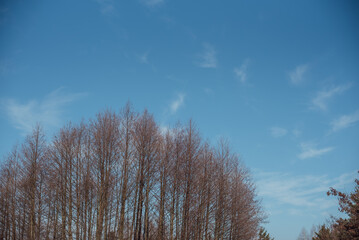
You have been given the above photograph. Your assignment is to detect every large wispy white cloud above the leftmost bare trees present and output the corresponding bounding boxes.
[1,88,85,134]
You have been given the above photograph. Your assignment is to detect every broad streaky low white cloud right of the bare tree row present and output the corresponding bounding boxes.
[254,171,356,210]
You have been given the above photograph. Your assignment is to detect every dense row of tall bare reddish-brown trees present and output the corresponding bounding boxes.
[0,104,263,240]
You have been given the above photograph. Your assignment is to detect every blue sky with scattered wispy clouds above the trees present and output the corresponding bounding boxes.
[0,0,359,240]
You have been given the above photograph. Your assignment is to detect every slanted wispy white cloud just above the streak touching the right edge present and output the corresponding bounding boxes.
[311,84,351,111]
